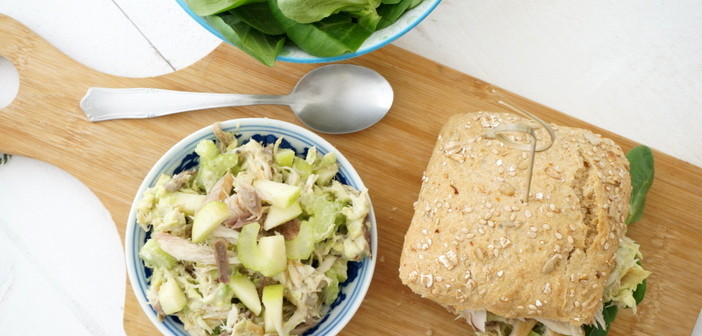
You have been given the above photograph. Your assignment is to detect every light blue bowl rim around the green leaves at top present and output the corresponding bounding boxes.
[176,0,441,63]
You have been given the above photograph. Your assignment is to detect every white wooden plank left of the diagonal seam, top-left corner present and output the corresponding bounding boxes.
[0,0,173,77]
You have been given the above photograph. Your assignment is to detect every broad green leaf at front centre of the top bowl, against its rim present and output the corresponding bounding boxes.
[268,0,353,57]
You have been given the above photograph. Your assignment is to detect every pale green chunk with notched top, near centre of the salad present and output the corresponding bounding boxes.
[236,223,287,277]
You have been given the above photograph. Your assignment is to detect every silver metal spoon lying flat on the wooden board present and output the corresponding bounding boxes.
[80,64,393,134]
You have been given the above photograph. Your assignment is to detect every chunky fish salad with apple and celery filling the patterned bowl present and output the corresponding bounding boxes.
[137,125,371,336]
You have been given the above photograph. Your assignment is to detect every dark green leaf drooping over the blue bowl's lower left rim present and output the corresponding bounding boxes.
[205,13,285,66]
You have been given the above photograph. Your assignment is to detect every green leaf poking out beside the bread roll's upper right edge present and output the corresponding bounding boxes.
[626,146,654,224]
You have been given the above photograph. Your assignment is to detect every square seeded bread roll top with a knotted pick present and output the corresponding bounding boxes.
[400,112,631,326]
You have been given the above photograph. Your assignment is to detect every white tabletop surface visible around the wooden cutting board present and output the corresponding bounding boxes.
[0,0,702,335]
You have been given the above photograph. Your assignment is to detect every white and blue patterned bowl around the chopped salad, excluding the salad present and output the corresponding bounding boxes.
[125,118,378,336]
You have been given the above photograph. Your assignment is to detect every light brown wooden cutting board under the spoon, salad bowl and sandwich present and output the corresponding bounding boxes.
[0,15,702,335]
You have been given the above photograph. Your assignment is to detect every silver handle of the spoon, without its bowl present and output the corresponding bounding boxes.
[80,88,289,121]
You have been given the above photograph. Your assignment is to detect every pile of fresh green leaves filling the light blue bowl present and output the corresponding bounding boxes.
[185,0,422,66]
